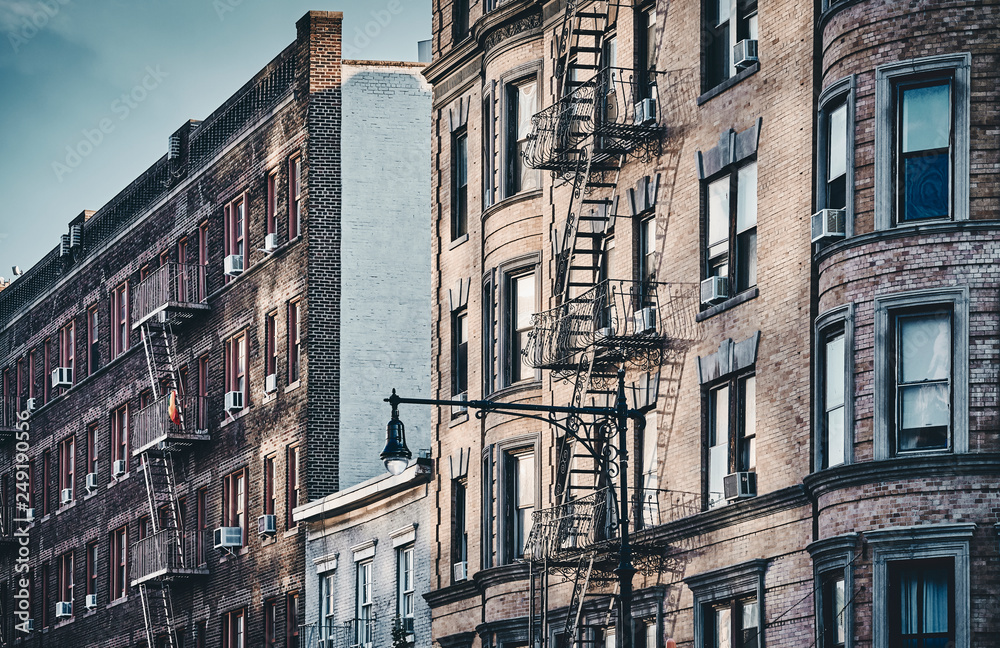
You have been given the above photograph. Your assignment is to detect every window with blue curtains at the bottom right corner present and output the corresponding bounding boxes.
[888,558,955,648]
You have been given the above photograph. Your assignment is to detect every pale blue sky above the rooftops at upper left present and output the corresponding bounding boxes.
[0,0,431,278]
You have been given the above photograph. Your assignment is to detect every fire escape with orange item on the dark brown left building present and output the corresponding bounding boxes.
[130,263,208,648]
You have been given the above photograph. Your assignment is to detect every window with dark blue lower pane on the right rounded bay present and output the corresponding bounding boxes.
[895,77,953,222]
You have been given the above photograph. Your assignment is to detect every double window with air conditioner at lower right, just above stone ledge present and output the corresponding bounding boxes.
[706,374,757,507]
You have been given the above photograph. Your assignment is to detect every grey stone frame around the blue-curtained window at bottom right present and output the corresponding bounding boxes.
[865,523,976,648]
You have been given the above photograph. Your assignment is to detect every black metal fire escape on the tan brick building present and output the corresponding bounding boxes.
[524,0,700,648]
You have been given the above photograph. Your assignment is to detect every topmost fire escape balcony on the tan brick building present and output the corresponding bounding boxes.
[524,68,663,172]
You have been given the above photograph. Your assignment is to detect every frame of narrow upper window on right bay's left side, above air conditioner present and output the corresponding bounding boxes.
[816,74,857,229]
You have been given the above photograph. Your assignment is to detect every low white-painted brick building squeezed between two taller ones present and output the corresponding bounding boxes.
[295,458,434,648]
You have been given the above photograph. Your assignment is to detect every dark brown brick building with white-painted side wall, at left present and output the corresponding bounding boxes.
[0,12,430,648]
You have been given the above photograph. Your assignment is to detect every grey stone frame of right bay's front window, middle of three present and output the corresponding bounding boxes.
[874,286,970,461]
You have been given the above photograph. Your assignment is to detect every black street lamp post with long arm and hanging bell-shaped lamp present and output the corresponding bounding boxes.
[381,369,646,648]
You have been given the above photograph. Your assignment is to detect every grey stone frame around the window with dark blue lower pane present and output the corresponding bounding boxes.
[874,52,972,230]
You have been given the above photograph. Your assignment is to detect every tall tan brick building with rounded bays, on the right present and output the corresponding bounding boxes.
[422,0,1000,648]
